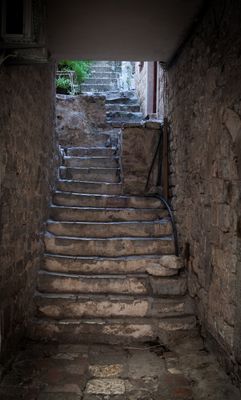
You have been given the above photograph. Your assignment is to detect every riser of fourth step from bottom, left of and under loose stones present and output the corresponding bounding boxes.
[43,255,179,276]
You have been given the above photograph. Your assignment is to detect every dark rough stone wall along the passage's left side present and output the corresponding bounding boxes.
[0,64,55,360]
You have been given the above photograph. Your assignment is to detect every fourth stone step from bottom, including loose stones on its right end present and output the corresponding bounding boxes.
[42,254,183,276]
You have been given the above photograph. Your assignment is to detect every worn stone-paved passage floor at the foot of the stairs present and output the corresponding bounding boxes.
[0,339,241,400]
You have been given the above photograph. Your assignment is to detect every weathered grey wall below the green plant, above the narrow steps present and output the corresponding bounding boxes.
[56,95,106,146]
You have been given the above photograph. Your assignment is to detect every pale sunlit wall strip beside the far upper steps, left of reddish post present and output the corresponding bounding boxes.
[135,61,148,116]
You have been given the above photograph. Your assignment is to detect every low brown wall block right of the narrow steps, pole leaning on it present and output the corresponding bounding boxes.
[121,121,160,194]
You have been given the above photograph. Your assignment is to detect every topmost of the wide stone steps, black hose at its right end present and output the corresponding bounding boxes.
[53,192,163,208]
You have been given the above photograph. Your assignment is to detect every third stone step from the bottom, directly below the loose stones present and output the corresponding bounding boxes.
[37,270,187,297]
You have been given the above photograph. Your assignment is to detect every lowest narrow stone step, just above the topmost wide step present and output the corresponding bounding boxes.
[56,179,122,195]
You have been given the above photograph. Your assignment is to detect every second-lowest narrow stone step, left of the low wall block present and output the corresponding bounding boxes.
[59,166,120,183]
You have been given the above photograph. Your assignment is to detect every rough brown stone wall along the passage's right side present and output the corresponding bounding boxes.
[167,0,241,376]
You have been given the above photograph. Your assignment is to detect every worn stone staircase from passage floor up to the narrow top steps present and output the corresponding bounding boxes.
[29,127,196,343]
